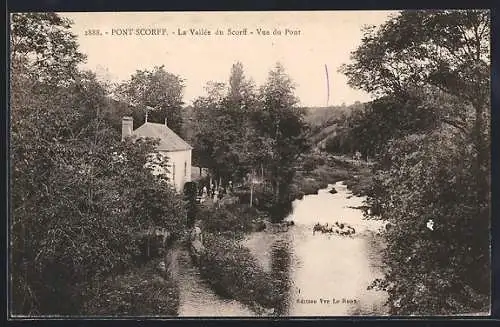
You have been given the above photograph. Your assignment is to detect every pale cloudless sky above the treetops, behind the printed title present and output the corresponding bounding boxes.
[61,11,395,106]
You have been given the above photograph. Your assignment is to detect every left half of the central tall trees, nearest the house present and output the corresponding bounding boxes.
[193,63,257,181]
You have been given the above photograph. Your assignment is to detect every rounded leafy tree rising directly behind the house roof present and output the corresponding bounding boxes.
[116,66,184,134]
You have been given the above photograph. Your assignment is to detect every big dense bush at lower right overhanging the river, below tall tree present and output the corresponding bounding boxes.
[369,134,490,315]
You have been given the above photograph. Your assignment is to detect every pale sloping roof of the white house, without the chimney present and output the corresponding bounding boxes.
[132,122,193,151]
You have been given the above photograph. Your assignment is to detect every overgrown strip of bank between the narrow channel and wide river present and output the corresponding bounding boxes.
[188,204,281,315]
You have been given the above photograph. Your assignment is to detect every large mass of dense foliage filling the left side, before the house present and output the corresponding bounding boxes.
[10,13,185,314]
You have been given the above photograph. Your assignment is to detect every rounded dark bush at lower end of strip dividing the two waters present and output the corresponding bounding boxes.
[200,235,283,308]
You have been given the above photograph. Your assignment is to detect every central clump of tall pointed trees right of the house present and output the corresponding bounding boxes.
[193,63,308,220]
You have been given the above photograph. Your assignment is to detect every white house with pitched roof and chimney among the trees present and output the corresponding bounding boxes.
[122,117,193,192]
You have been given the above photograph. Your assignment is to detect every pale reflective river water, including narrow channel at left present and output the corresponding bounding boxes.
[179,182,387,316]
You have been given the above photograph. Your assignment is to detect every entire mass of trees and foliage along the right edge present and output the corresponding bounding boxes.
[342,10,490,314]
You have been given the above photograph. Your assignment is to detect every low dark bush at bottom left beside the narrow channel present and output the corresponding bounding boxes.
[83,260,179,316]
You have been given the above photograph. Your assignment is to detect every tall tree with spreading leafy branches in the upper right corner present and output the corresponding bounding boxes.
[341,10,490,205]
